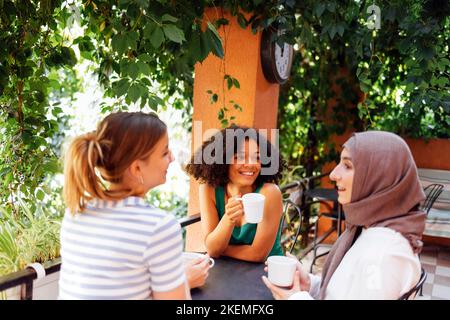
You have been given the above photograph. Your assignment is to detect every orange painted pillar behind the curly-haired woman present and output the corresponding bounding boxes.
[186,8,279,251]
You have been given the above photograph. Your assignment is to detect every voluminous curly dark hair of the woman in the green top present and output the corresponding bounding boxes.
[184,125,286,188]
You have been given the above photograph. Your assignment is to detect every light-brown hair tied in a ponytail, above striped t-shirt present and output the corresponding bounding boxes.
[64,112,167,214]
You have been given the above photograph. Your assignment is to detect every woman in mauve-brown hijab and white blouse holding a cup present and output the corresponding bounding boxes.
[263,131,426,299]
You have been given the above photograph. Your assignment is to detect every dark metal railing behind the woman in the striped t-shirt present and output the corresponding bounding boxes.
[0,213,201,300]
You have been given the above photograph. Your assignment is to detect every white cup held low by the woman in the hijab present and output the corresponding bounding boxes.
[267,256,297,287]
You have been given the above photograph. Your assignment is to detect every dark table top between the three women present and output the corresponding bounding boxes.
[191,257,273,300]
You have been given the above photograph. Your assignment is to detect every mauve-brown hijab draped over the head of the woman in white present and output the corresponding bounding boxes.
[320,131,426,299]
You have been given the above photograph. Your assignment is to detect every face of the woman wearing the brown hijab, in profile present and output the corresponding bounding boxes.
[330,148,355,204]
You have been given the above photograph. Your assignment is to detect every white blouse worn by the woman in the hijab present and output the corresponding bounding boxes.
[289,227,421,300]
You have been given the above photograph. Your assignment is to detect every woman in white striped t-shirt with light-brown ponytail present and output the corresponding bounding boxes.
[59,112,209,300]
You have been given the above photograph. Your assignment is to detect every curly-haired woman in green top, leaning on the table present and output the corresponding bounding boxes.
[186,126,283,262]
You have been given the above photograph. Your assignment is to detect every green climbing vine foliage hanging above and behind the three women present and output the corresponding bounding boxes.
[0,0,450,212]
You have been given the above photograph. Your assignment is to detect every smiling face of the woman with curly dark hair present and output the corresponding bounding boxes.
[228,139,261,187]
